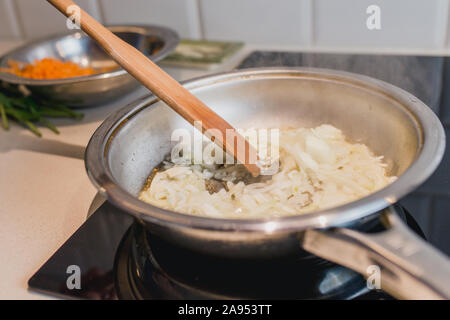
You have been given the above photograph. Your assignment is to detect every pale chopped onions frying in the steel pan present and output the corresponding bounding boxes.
[139,125,396,219]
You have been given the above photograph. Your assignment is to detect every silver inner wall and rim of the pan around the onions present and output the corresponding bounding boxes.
[86,68,445,235]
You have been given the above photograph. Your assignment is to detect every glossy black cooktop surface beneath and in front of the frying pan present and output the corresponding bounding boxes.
[28,202,423,300]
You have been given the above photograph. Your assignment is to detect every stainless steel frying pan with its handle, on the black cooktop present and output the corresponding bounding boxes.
[86,68,450,299]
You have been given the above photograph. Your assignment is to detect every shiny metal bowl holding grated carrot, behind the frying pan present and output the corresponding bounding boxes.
[0,25,179,107]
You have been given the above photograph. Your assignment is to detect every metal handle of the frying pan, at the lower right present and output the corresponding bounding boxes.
[302,207,450,299]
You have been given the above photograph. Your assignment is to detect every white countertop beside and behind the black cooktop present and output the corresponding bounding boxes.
[0,42,250,299]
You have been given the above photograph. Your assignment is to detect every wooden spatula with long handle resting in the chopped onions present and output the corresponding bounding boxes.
[47,0,260,177]
